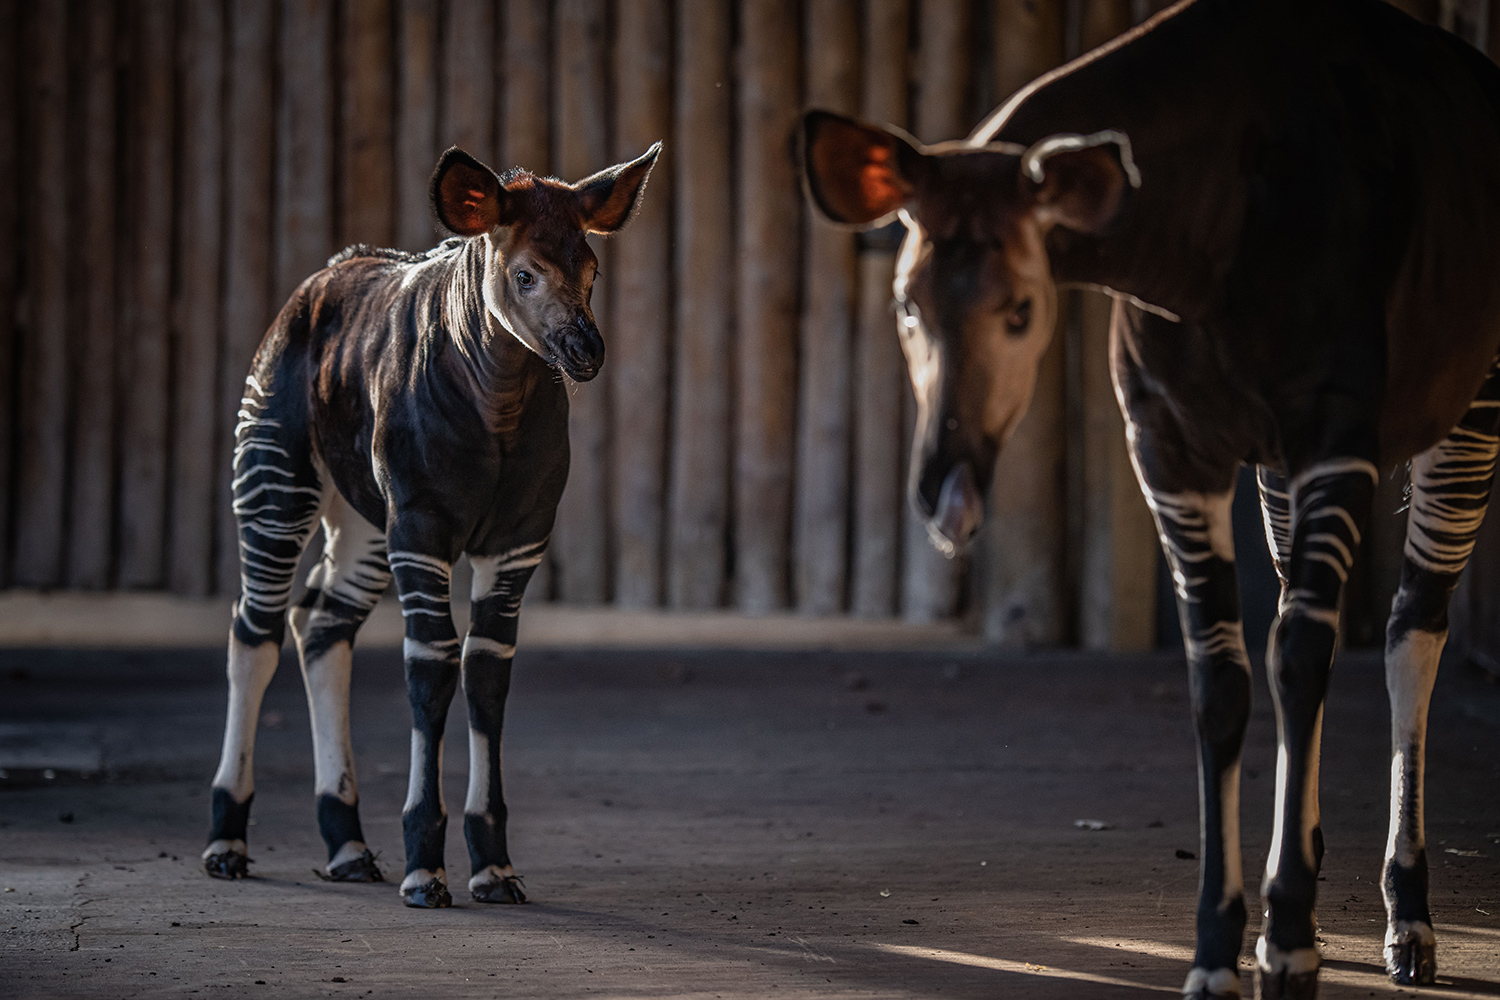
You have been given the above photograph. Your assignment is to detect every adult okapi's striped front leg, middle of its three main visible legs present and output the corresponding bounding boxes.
[1256,459,1379,999]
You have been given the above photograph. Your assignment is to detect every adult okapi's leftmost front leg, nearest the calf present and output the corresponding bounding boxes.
[1137,476,1250,1000]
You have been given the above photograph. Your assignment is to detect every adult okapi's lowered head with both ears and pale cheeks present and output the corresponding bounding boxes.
[803,111,1139,555]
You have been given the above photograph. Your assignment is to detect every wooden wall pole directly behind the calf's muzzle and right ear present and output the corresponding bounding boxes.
[552,0,614,604]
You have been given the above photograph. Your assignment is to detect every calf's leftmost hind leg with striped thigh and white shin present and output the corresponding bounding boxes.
[203,378,323,879]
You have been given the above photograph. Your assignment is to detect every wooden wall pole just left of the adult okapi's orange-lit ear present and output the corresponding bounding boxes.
[735,0,803,615]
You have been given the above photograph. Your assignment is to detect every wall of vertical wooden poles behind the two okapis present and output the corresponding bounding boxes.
[0,0,1500,648]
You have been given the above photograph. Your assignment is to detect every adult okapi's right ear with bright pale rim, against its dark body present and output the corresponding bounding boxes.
[1022,129,1140,232]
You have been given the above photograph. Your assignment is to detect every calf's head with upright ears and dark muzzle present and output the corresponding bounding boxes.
[431,142,662,382]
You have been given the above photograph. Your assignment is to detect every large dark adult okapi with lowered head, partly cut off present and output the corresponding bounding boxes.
[803,0,1500,997]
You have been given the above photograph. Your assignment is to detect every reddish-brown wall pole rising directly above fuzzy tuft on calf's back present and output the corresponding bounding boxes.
[338,0,393,246]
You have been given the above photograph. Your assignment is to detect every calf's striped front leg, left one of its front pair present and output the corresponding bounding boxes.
[389,542,459,907]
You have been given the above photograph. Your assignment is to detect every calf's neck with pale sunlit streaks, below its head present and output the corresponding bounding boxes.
[432,235,561,433]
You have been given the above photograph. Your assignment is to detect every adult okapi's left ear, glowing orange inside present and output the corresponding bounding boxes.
[801,111,923,226]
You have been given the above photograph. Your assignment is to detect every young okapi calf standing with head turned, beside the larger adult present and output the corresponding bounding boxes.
[203,142,662,907]
